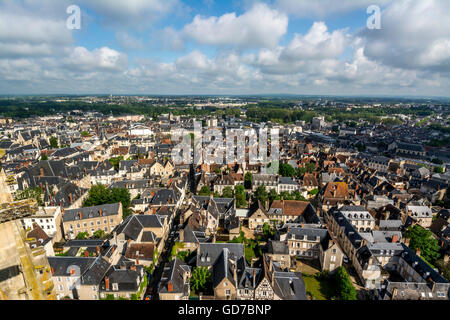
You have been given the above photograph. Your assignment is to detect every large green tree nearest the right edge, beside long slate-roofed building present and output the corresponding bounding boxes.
[404,224,441,263]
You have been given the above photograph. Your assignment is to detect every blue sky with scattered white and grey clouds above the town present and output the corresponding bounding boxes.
[0,0,450,97]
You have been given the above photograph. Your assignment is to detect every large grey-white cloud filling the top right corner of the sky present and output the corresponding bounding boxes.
[358,0,450,72]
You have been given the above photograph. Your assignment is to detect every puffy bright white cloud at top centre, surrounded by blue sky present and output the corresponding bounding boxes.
[183,4,289,48]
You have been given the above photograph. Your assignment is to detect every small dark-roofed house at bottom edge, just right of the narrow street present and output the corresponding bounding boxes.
[158,258,191,300]
